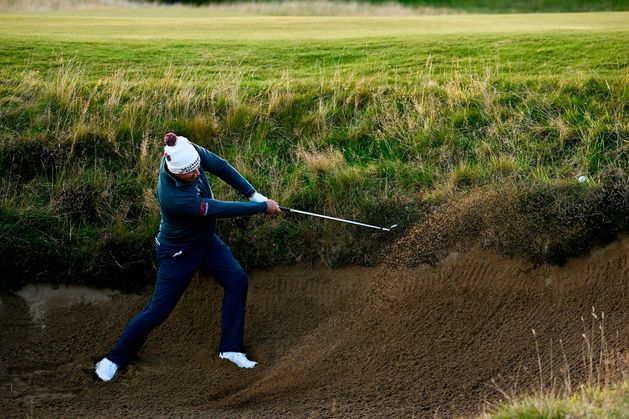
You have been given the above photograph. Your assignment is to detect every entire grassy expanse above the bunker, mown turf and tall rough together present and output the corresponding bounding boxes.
[0,9,629,285]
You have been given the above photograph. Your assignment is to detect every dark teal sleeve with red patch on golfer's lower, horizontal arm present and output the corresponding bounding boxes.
[170,196,266,218]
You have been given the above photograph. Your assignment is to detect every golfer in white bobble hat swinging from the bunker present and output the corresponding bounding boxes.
[96,132,281,381]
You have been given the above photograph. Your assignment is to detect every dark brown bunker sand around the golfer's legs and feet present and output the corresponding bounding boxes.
[0,237,629,417]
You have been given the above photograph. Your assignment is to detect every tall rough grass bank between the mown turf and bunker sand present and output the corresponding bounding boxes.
[0,62,629,288]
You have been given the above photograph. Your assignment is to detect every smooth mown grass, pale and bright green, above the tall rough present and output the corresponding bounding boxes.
[0,12,629,84]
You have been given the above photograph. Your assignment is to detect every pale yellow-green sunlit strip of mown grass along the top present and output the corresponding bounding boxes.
[0,9,627,42]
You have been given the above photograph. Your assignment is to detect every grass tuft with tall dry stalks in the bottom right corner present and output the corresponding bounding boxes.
[480,307,629,419]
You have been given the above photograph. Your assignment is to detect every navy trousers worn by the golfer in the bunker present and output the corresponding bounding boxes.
[107,234,247,366]
